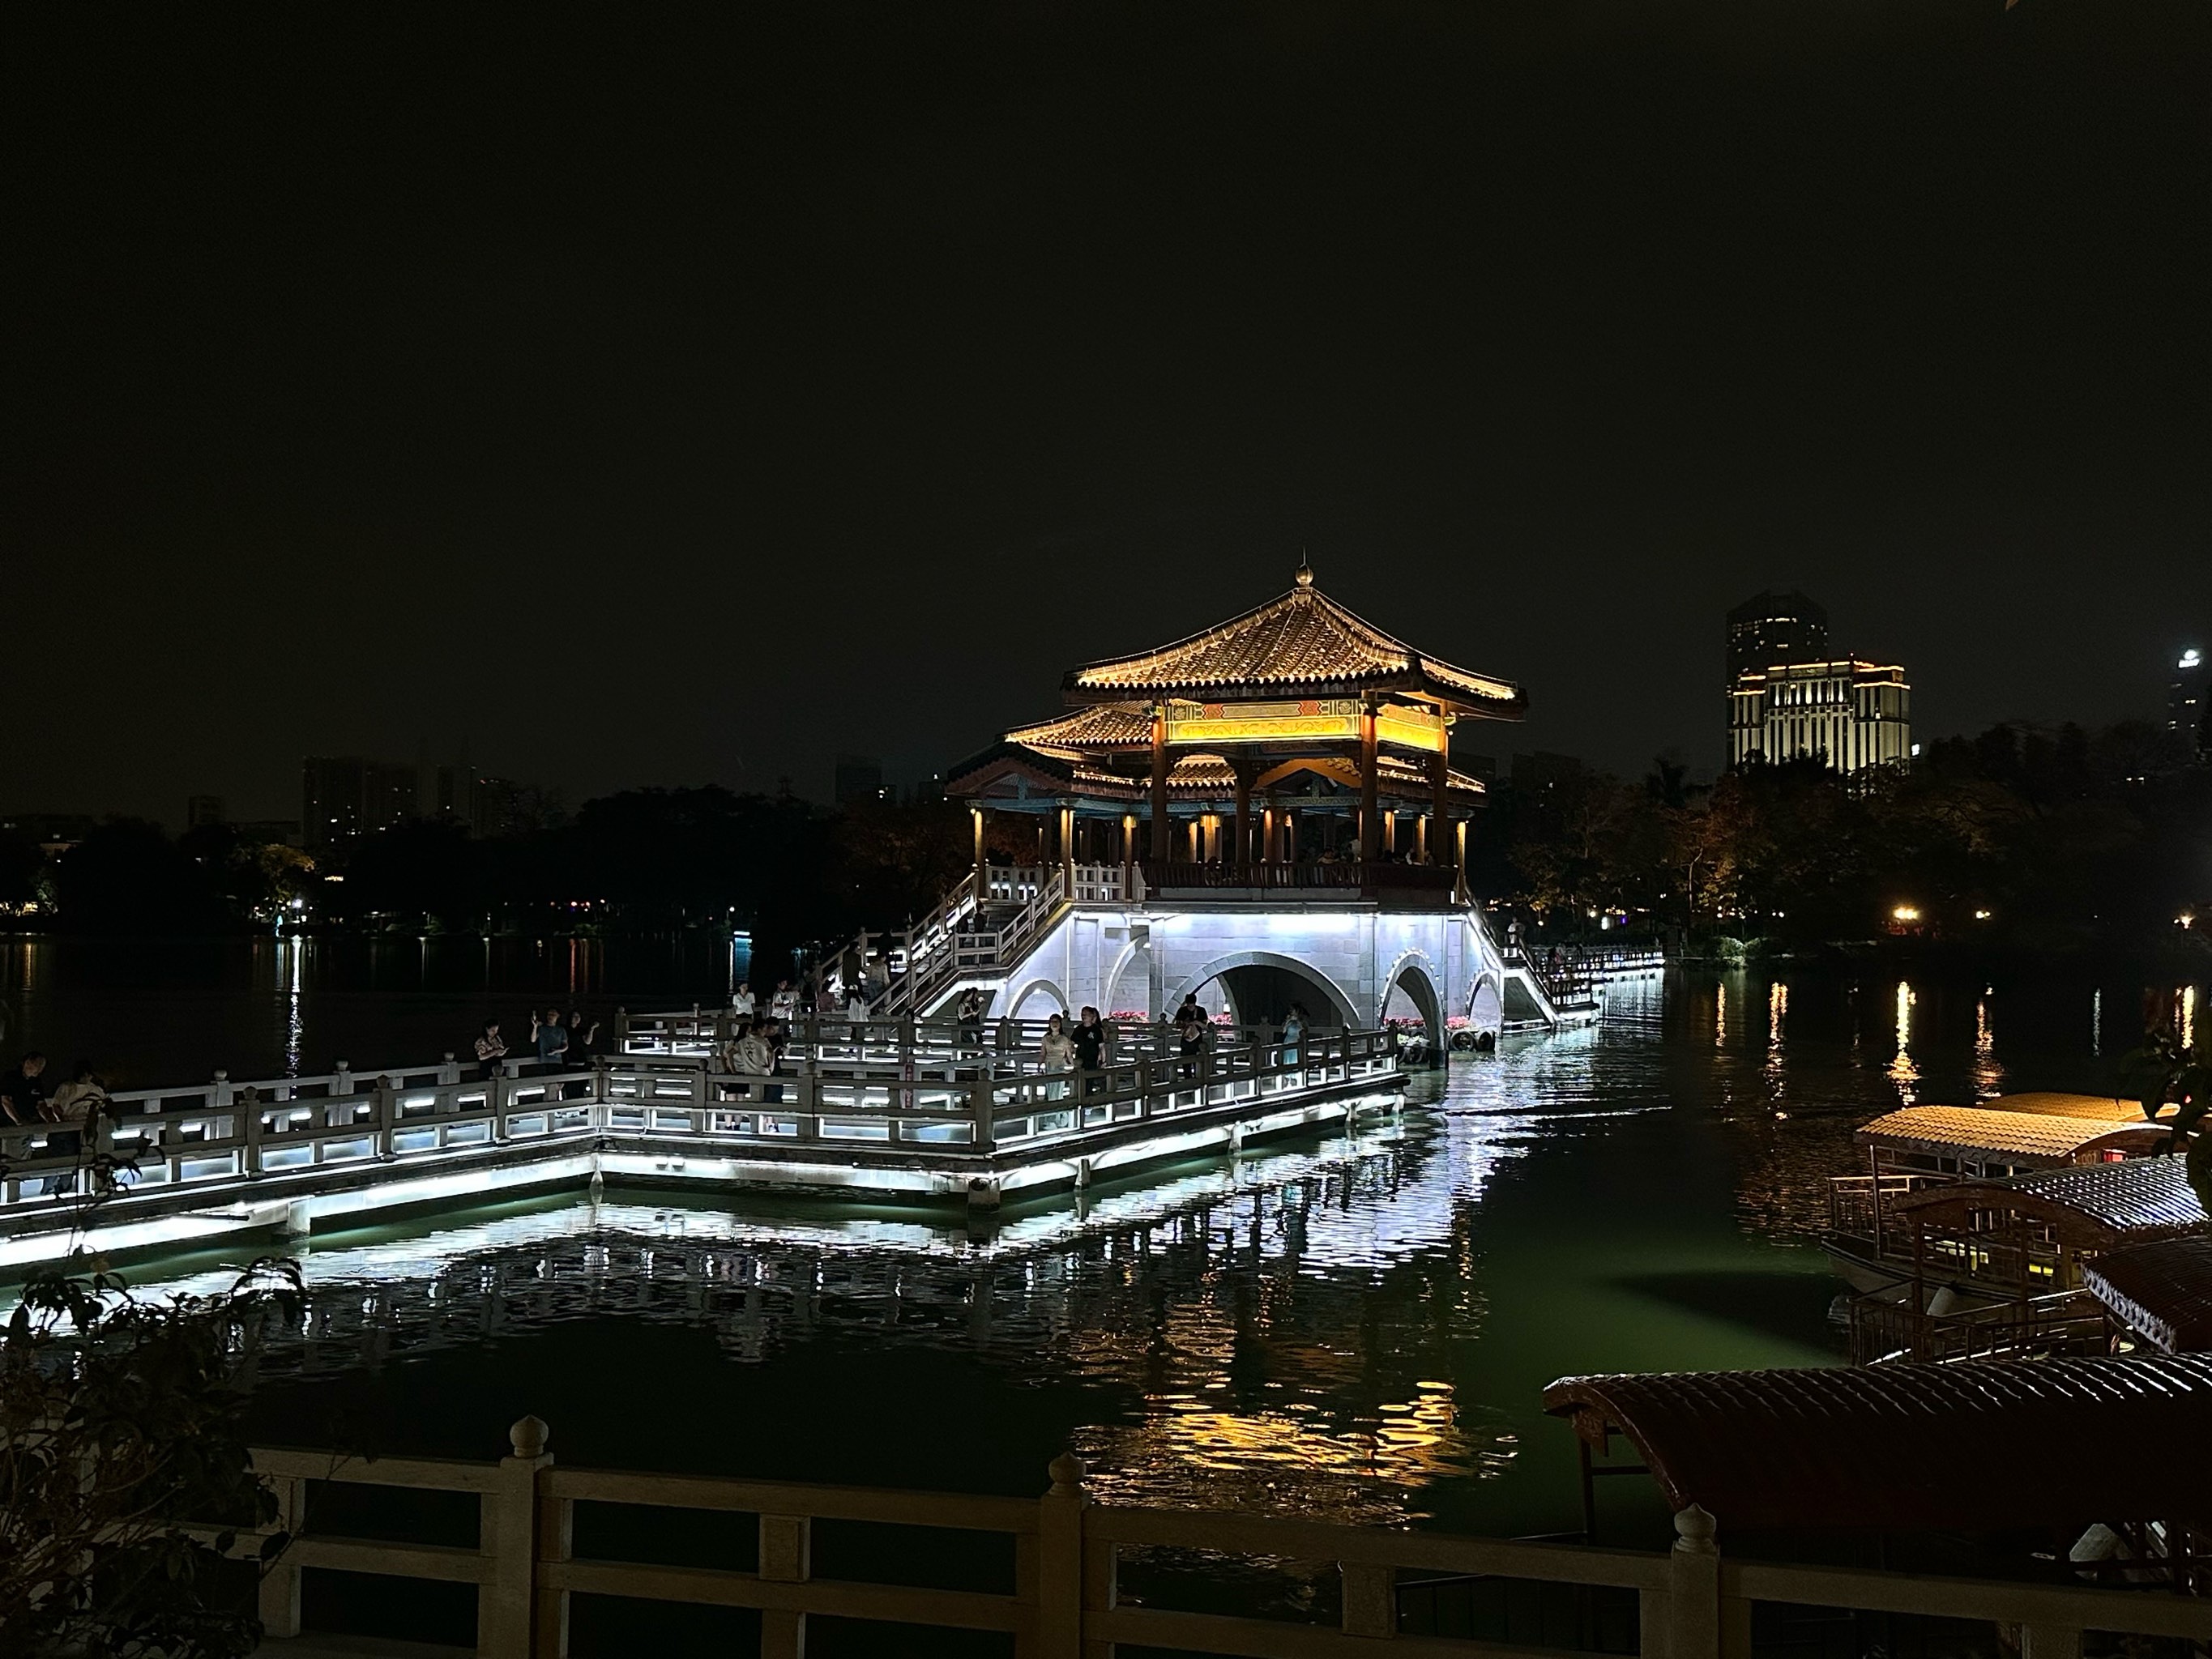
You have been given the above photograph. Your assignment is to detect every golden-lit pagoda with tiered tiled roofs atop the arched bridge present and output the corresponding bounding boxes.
[945,564,1527,889]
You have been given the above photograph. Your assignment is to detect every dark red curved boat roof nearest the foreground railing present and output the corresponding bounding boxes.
[1544,1363,2212,1540]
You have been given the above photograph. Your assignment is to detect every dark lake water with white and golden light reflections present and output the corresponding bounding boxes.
[6,942,2194,1654]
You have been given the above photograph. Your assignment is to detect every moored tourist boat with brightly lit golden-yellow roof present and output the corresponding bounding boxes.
[1827,1095,2167,1296]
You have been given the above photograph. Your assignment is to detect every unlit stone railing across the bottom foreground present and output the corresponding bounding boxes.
[237,1418,2212,1659]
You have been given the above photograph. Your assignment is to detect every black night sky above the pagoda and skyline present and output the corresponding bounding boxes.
[0,0,2212,823]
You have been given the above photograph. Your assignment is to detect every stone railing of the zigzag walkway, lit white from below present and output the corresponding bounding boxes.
[0,1015,1398,1223]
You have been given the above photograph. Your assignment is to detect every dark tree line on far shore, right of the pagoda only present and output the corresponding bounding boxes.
[1471,723,2212,951]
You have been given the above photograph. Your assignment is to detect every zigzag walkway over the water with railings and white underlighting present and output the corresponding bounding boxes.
[0,1015,1400,1268]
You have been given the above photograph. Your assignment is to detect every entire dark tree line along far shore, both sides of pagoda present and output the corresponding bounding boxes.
[0,723,2212,969]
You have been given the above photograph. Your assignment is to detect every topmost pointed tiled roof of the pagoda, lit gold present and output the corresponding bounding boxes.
[1061,566,1528,719]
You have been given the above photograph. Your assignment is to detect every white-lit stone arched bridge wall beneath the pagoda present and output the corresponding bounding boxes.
[977,900,1506,1030]
